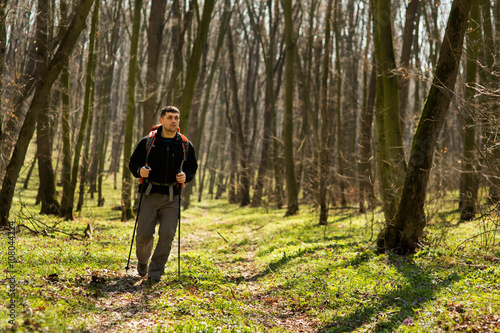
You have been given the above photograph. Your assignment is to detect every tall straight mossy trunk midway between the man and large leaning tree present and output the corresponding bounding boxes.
[281,0,299,216]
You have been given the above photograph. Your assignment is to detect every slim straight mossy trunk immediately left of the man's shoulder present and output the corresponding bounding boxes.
[122,0,142,221]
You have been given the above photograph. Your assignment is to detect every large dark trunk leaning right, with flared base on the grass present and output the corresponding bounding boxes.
[377,0,472,254]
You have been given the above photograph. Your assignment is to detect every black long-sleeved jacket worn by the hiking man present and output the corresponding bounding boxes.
[128,126,198,194]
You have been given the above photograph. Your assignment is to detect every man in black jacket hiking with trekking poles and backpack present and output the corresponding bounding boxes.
[129,106,198,283]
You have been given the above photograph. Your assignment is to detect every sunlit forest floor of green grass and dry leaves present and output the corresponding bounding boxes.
[0,187,500,332]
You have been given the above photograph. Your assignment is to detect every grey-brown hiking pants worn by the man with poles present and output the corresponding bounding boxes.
[136,193,179,280]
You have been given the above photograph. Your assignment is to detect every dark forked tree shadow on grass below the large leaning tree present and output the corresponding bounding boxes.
[319,257,459,332]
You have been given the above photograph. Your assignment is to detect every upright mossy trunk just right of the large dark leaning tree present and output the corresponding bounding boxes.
[459,0,481,221]
